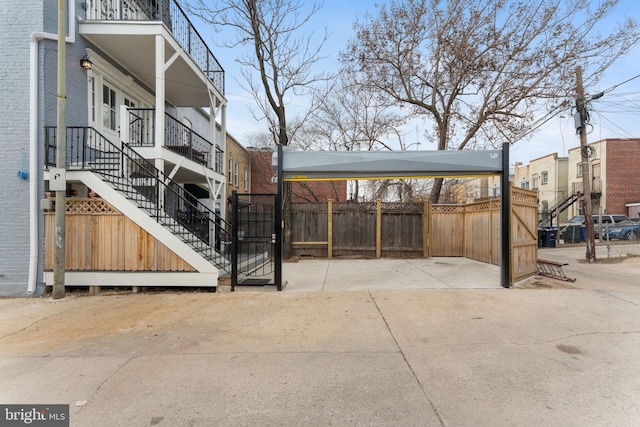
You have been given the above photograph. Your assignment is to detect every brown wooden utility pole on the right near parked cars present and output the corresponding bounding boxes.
[576,66,596,263]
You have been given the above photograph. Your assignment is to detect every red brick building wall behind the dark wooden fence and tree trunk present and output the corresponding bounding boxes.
[249,148,347,203]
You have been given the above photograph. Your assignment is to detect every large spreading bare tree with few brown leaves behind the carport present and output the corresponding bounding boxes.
[342,0,639,203]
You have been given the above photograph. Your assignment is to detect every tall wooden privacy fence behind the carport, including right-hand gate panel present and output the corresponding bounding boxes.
[292,188,537,281]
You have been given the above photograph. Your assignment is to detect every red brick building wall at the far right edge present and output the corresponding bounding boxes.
[606,138,640,214]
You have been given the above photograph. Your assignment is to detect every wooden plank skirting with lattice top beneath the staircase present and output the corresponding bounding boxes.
[44,198,195,271]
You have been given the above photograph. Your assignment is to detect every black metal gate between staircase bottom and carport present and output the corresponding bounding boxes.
[231,191,282,291]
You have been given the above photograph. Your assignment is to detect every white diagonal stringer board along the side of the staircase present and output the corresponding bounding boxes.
[67,171,219,277]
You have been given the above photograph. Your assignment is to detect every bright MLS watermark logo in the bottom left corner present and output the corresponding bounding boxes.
[0,405,69,427]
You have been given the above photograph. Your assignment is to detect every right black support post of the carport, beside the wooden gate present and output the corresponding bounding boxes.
[500,143,511,288]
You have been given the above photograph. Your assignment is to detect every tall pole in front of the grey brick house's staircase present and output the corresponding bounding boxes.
[49,0,67,299]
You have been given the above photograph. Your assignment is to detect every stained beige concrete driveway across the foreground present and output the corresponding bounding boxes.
[0,248,640,426]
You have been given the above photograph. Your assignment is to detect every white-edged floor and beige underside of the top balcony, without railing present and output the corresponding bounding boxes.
[79,21,224,108]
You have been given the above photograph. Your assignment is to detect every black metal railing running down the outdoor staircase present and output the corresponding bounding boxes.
[45,126,231,273]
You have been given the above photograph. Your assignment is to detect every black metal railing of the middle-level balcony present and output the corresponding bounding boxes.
[125,108,224,174]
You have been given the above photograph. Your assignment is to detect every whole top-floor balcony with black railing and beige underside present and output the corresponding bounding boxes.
[79,0,224,107]
